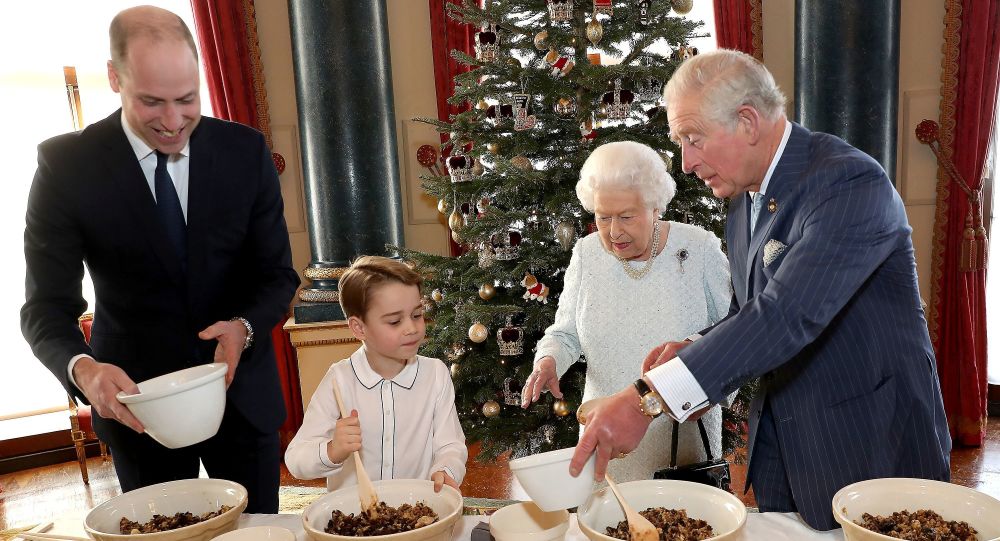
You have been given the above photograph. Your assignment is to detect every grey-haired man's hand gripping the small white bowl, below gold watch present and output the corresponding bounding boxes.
[569,385,652,482]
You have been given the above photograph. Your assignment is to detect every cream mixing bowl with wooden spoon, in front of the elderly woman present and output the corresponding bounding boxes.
[577,479,747,541]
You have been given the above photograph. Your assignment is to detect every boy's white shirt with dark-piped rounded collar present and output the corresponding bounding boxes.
[285,346,469,490]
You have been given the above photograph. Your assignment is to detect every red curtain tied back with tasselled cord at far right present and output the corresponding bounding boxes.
[928,0,1000,446]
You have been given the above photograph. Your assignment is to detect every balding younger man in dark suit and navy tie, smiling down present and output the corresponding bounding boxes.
[21,6,299,513]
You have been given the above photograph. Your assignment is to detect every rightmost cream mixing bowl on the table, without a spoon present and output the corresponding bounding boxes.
[833,478,1000,541]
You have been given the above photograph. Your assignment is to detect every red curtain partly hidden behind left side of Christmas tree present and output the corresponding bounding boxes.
[428,0,479,255]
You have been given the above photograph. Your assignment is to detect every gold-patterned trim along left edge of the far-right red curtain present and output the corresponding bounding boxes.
[927,0,962,345]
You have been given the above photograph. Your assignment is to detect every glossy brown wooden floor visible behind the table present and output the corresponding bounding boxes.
[0,417,1000,530]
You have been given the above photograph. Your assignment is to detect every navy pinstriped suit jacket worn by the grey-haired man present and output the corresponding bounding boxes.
[681,124,951,530]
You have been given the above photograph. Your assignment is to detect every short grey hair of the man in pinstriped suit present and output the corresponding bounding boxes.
[663,49,785,129]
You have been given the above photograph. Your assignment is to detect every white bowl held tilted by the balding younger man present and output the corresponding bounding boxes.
[117,363,227,449]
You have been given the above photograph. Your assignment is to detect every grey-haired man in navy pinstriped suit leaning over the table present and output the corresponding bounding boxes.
[570,51,951,530]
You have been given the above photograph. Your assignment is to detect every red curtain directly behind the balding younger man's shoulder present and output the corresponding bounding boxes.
[191,0,272,146]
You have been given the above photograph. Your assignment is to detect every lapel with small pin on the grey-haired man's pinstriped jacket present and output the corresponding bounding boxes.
[742,123,809,297]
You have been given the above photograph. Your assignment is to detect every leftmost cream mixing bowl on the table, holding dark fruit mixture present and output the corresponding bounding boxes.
[83,479,247,541]
